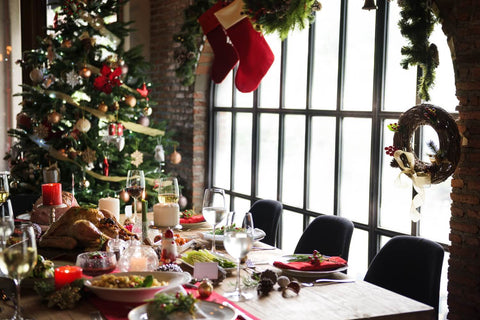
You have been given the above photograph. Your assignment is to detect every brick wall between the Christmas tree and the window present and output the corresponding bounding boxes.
[150,0,212,209]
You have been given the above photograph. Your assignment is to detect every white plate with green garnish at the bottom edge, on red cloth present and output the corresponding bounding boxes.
[128,301,235,320]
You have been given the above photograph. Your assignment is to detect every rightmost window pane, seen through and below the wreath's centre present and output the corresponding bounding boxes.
[419,126,452,244]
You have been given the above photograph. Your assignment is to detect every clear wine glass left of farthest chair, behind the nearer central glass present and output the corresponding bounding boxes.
[202,188,227,253]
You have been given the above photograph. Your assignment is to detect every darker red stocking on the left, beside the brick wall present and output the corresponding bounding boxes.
[198,1,238,83]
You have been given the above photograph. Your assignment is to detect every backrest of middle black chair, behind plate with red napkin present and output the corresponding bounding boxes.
[295,215,354,261]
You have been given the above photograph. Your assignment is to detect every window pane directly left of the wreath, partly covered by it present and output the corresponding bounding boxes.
[378,119,412,234]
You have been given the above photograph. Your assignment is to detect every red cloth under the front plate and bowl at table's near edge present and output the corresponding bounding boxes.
[89,289,260,320]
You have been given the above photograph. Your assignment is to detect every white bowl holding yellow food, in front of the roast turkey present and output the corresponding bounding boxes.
[85,271,192,303]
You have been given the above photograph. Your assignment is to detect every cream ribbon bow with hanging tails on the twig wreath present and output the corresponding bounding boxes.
[393,150,430,222]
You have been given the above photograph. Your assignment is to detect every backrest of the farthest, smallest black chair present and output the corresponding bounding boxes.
[250,200,283,246]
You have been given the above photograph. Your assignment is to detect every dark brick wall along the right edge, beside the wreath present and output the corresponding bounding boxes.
[437,0,480,320]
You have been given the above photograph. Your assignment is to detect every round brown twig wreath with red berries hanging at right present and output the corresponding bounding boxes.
[386,104,460,184]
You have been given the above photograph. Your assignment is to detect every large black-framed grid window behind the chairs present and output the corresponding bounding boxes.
[210,0,457,316]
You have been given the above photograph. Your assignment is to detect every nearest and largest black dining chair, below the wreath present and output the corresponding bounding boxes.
[364,236,444,316]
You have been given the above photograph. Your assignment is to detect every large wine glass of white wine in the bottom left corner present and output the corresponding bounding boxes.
[0,224,37,320]
